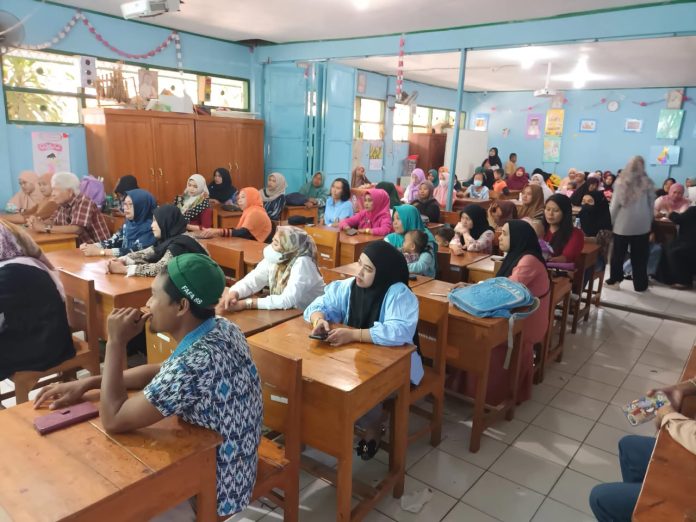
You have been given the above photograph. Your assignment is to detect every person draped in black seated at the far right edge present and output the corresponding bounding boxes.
[655,207,696,290]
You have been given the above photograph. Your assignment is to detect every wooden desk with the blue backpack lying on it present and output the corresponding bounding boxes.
[413,280,523,453]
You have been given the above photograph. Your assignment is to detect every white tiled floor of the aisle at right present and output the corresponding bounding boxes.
[5,281,696,522]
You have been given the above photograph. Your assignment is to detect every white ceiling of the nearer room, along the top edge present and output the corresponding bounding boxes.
[53,0,670,43]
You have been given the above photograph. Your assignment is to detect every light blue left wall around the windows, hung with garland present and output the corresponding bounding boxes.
[0,0,261,207]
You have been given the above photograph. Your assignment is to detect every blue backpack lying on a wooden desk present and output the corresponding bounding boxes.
[448,277,540,369]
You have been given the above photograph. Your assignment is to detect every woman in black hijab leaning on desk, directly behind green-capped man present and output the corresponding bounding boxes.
[107,205,207,277]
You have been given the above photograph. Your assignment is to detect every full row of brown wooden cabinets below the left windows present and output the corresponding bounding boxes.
[84,109,263,204]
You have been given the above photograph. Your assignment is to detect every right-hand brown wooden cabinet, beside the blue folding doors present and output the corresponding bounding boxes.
[196,116,264,189]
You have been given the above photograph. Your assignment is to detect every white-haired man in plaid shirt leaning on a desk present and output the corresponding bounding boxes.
[28,172,111,243]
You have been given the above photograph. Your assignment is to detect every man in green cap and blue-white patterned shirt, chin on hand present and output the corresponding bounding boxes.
[35,254,263,516]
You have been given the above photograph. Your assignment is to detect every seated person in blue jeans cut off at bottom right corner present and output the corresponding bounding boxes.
[590,377,696,522]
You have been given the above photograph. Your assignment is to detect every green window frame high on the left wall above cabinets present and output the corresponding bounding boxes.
[0,49,251,127]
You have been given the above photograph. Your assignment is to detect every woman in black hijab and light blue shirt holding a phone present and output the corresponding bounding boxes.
[304,239,423,460]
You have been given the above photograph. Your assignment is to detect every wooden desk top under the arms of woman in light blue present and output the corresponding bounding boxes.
[248,317,414,392]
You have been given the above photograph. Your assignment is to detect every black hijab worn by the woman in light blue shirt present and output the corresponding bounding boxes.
[346,240,408,328]
